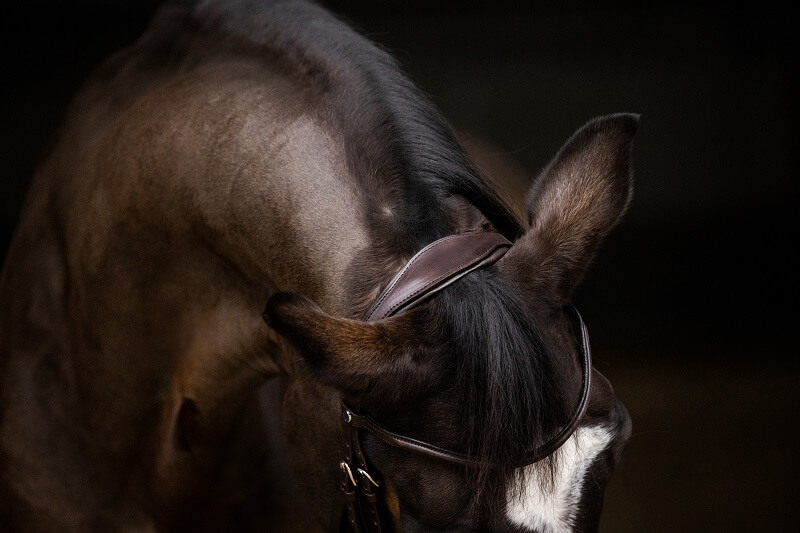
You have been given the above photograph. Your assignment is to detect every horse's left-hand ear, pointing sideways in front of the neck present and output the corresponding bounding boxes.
[263,292,418,394]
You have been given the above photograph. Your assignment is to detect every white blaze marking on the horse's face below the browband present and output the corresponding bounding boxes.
[506,426,614,533]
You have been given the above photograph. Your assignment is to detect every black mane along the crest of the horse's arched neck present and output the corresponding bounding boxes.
[182,0,522,248]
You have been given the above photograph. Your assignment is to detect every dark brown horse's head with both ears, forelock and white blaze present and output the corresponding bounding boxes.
[267,115,638,531]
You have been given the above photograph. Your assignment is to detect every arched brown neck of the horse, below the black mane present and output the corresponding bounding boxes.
[0,2,506,524]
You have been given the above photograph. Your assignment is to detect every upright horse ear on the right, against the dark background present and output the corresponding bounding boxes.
[499,114,639,307]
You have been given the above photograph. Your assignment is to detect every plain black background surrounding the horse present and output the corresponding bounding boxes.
[0,0,800,531]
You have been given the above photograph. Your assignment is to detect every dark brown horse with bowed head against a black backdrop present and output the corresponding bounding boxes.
[0,0,639,532]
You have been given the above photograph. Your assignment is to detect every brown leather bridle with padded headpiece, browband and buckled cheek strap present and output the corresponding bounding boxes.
[339,231,592,533]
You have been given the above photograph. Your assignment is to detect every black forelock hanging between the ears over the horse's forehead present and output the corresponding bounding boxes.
[440,269,570,505]
